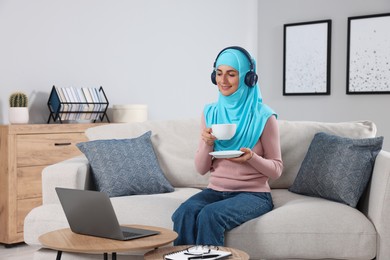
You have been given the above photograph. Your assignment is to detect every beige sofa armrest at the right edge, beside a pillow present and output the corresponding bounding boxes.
[361,151,390,260]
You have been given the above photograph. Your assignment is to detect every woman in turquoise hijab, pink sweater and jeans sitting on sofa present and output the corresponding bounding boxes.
[172,46,283,246]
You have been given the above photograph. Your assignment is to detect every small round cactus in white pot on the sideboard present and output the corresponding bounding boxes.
[8,92,29,124]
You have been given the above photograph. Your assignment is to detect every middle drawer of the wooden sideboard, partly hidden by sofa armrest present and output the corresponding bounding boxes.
[17,166,45,199]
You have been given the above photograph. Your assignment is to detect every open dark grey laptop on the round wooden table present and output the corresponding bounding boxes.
[55,187,160,241]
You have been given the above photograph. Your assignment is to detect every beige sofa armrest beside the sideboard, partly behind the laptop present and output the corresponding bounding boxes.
[42,155,90,204]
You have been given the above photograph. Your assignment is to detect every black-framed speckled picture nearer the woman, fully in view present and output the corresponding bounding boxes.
[283,20,332,96]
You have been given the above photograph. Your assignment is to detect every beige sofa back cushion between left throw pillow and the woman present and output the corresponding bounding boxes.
[86,119,208,188]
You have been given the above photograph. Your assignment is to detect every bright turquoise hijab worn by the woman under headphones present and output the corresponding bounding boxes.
[204,49,277,151]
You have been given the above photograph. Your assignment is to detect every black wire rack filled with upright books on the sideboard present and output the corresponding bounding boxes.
[47,86,110,123]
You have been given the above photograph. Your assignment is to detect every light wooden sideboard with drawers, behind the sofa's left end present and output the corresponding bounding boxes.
[0,123,101,244]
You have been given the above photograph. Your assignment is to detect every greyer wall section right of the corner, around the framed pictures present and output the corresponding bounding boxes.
[257,0,390,150]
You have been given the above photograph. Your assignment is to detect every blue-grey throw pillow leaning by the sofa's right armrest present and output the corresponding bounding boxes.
[289,133,383,207]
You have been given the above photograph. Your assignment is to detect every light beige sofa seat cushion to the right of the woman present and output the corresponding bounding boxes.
[226,189,376,259]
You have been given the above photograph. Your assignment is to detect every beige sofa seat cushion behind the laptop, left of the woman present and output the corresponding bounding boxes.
[24,188,200,245]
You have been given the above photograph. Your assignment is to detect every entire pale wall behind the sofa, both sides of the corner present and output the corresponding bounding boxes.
[0,0,390,150]
